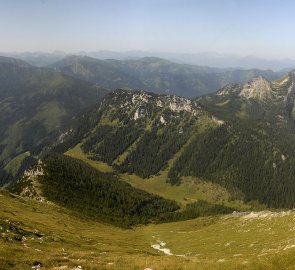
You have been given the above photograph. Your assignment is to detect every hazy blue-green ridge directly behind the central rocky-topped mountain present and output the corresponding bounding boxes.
[50,56,281,97]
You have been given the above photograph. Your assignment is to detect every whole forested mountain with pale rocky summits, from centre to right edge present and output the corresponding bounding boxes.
[63,73,295,208]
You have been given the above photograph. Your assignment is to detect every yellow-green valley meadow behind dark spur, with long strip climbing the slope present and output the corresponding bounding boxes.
[65,115,230,206]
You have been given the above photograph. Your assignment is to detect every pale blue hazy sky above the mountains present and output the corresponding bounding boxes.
[0,0,295,58]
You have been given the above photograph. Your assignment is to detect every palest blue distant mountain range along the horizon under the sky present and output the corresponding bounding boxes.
[0,51,295,72]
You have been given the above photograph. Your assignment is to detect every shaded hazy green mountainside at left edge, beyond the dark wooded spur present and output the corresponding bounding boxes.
[0,57,106,185]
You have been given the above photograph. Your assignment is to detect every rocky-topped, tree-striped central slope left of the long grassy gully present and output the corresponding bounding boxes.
[59,90,212,177]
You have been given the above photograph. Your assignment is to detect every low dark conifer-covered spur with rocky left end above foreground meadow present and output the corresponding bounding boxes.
[13,154,179,227]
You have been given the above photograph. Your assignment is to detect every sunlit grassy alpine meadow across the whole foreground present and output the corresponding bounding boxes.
[0,189,295,270]
